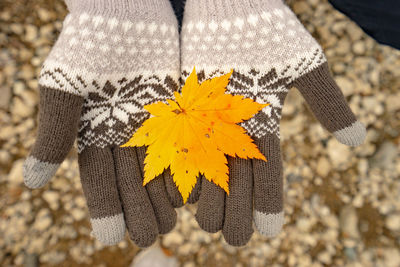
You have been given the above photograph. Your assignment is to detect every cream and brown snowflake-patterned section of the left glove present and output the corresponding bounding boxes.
[39,13,179,152]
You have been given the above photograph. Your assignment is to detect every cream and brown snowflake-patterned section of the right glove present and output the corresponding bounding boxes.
[181,1,326,138]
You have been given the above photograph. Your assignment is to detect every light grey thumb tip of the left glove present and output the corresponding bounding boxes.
[22,156,60,189]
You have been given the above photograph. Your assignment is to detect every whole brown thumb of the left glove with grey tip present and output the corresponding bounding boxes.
[23,86,83,188]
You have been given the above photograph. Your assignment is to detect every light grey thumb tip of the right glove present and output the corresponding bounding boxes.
[333,121,367,147]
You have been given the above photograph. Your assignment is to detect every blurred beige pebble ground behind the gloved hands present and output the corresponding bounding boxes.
[0,0,400,267]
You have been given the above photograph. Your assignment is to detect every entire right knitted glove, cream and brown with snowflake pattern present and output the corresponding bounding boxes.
[181,0,366,246]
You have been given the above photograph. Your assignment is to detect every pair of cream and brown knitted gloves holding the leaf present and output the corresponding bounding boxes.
[24,0,366,247]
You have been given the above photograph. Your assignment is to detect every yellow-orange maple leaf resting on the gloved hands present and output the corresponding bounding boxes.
[122,69,268,203]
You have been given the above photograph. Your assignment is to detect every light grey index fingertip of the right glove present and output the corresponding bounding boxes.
[254,210,285,237]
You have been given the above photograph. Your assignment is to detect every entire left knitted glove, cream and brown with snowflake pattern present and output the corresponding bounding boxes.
[24,0,180,247]
